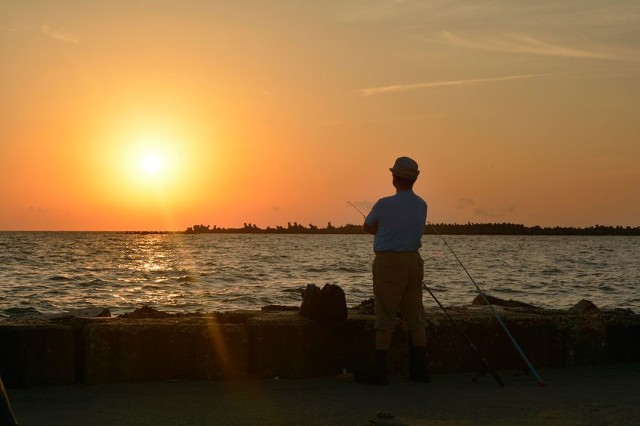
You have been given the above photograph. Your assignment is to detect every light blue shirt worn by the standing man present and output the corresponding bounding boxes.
[365,190,427,252]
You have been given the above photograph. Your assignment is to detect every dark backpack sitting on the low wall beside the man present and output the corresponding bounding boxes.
[300,284,348,321]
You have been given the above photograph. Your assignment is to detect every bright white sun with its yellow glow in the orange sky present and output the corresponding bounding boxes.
[94,119,208,211]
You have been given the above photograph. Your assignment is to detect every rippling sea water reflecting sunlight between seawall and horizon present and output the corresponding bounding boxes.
[0,232,640,318]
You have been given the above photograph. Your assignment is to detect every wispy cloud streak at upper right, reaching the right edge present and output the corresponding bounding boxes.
[436,31,637,60]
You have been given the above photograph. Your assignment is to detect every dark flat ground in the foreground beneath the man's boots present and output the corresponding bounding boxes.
[8,364,640,426]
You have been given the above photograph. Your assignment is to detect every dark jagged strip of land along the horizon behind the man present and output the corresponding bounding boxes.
[184,222,640,235]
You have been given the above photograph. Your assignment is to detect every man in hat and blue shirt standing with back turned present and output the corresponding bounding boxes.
[356,157,430,385]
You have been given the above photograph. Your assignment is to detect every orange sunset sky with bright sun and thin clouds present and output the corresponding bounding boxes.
[0,0,640,231]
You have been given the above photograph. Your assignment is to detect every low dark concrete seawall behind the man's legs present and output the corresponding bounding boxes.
[0,299,640,387]
